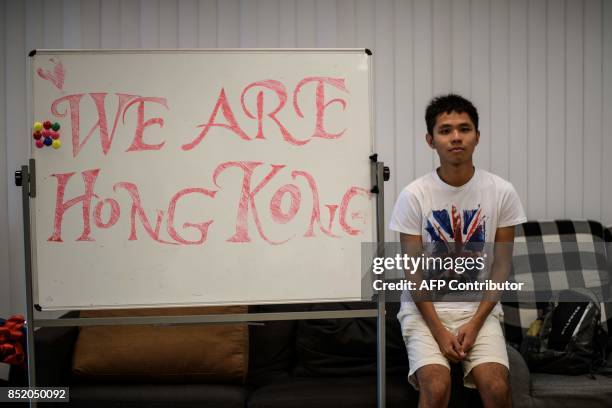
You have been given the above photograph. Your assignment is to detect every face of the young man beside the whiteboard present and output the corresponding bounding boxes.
[427,111,480,165]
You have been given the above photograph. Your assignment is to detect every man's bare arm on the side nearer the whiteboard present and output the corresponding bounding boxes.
[400,233,465,362]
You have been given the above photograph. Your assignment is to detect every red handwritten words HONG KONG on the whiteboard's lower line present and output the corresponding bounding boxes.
[48,161,371,245]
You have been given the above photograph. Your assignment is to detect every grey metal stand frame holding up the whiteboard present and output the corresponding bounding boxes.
[15,154,389,408]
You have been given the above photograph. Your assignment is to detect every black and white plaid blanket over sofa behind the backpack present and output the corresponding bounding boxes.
[502,220,612,347]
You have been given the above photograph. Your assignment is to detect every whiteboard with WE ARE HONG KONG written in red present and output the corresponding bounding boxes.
[31,49,376,310]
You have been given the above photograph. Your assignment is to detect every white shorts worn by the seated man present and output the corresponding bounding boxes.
[402,310,509,390]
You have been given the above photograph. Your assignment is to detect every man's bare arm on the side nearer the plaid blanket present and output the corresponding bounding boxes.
[457,226,514,352]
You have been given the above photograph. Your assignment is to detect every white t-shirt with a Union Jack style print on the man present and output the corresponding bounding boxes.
[389,169,527,326]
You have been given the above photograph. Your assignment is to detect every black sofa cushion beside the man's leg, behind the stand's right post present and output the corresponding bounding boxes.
[294,302,408,376]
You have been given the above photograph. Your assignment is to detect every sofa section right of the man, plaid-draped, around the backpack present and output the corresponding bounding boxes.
[502,220,612,407]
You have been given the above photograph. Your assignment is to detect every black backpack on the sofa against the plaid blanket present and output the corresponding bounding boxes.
[521,288,611,375]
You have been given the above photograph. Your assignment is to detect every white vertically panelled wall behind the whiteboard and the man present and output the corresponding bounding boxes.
[0,0,612,315]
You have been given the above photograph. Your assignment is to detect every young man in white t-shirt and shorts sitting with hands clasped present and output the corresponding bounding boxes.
[389,94,526,407]
